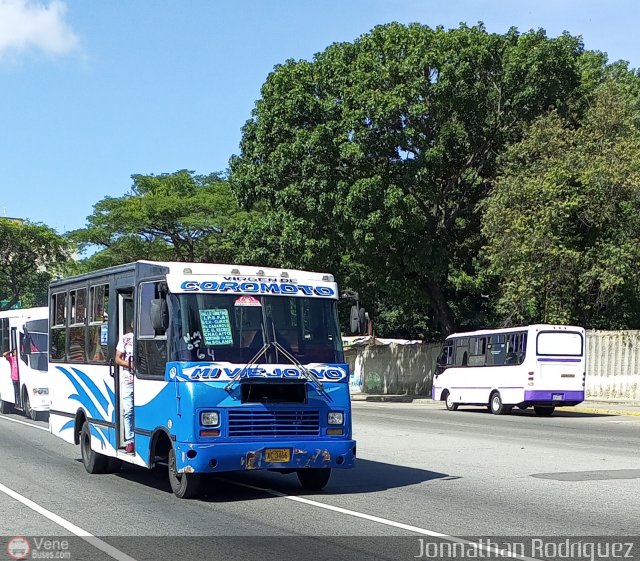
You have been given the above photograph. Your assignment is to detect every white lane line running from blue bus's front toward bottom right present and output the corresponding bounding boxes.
[228,478,542,561]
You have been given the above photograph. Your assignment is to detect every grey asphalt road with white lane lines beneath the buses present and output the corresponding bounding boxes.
[0,402,640,561]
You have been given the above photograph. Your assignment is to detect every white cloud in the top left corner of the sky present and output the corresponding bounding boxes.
[0,0,78,57]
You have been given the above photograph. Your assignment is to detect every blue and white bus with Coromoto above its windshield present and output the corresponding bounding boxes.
[49,261,356,498]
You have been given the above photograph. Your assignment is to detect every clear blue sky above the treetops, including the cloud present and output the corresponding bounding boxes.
[0,0,640,233]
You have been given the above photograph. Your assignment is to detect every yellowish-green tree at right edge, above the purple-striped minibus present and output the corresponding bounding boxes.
[483,80,640,329]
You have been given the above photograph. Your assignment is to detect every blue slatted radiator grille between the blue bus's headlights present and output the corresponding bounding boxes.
[229,409,320,437]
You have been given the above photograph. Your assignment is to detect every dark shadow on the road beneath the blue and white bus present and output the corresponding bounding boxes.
[110,460,452,502]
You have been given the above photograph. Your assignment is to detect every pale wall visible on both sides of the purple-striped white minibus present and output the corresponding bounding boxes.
[346,331,640,401]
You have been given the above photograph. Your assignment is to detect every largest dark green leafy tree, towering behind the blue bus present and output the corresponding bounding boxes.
[230,24,602,335]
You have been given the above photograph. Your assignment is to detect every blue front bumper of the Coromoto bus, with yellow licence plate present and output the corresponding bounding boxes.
[175,440,356,473]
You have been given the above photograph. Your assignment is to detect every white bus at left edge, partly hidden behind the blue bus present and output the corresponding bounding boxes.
[0,307,49,421]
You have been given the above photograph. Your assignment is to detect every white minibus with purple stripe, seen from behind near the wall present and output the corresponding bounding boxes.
[432,325,586,416]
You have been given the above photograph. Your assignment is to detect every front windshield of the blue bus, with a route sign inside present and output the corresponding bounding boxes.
[169,294,344,364]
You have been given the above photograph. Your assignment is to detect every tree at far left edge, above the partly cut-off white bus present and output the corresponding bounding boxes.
[0,218,71,310]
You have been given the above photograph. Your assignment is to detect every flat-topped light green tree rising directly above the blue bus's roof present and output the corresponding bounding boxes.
[70,170,247,269]
